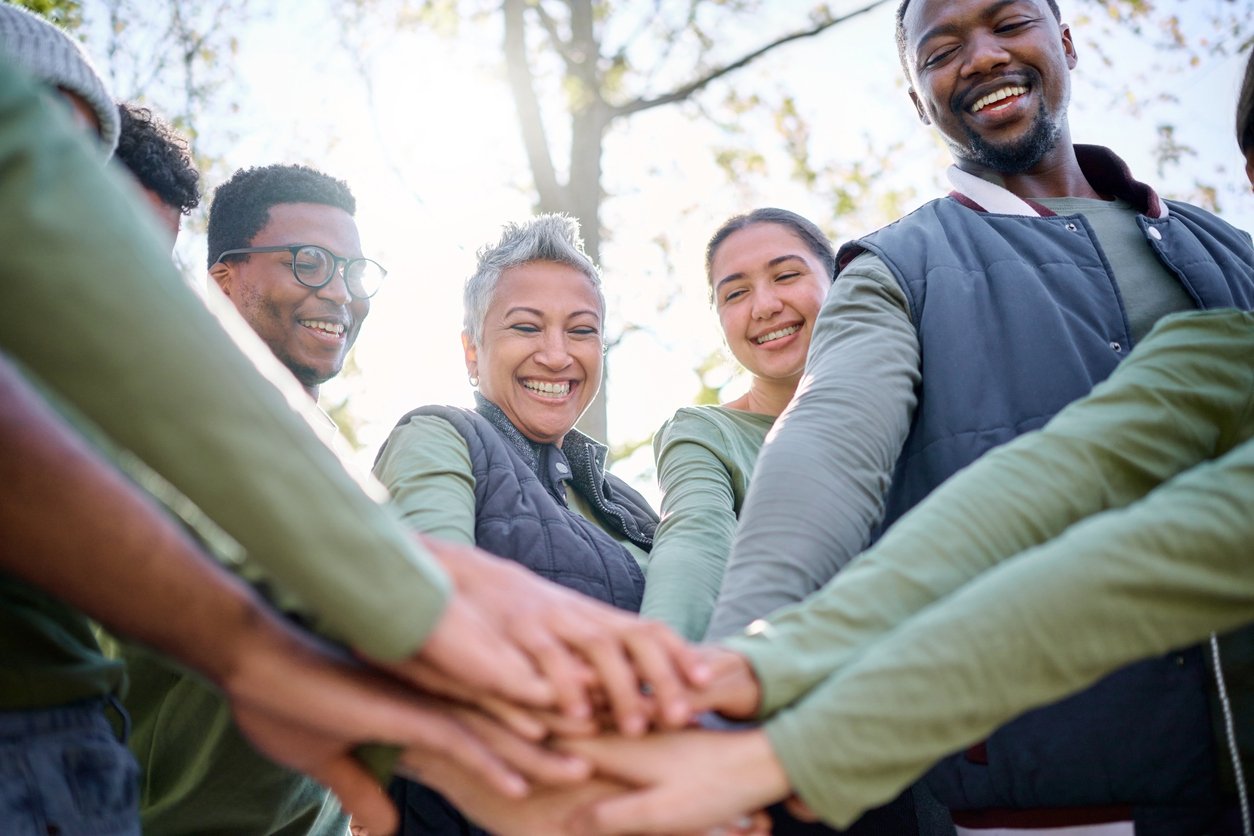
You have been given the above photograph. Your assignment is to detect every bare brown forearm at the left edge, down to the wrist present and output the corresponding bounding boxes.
[0,358,284,684]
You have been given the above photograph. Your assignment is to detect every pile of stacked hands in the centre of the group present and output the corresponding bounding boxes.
[219,539,790,836]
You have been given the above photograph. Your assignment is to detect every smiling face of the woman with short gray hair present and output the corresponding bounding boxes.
[461,261,603,444]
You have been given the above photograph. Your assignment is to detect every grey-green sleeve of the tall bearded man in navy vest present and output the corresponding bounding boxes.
[709,263,919,638]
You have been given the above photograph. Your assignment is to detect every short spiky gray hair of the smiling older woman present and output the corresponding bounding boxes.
[463,214,606,346]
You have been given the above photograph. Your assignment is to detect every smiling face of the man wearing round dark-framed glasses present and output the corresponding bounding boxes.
[209,203,370,399]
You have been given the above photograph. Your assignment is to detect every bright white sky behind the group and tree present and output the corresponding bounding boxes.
[85,0,1254,495]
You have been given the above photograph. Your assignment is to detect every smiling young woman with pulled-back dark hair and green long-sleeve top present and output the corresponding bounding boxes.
[641,208,835,640]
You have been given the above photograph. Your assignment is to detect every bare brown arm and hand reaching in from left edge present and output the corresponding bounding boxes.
[0,353,549,832]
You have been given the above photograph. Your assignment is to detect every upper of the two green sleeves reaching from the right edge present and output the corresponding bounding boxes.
[732,311,1254,714]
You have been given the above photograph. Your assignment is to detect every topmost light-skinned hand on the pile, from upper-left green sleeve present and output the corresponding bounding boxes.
[419,538,709,734]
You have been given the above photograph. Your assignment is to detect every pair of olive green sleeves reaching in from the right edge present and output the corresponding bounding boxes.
[730,311,1254,825]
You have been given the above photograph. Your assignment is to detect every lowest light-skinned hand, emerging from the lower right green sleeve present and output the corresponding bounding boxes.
[561,729,791,836]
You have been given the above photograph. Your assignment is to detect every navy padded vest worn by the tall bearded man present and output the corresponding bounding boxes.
[839,147,1254,833]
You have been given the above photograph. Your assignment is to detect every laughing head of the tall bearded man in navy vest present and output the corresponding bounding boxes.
[903,0,1076,174]
